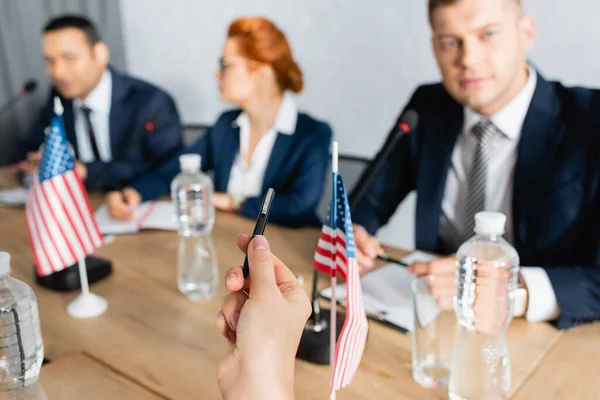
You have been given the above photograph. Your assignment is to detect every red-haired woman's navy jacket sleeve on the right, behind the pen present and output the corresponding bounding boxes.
[240,124,332,226]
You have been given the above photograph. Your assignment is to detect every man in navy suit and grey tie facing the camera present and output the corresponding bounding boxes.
[353,0,600,328]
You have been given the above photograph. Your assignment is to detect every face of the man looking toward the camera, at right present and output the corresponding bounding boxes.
[431,0,535,116]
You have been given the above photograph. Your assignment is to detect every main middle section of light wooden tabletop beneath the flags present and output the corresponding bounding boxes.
[0,171,592,400]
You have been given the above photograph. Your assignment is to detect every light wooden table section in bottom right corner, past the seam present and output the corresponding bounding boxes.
[514,323,600,400]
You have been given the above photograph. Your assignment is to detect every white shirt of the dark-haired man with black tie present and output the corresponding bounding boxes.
[73,69,112,163]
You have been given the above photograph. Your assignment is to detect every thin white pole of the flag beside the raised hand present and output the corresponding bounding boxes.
[329,142,338,400]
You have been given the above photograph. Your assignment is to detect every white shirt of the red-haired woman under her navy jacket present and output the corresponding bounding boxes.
[227,94,298,197]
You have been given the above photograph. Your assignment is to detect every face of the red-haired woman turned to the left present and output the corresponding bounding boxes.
[216,38,269,105]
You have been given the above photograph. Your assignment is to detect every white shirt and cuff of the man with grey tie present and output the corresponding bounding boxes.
[440,67,560,322]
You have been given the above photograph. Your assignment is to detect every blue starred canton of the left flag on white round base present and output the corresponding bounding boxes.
[39,115,75,182]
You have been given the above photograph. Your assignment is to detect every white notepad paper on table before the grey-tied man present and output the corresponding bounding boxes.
[319,251,437,332]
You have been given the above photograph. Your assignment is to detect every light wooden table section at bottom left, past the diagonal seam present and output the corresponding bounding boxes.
[40,353,164,400]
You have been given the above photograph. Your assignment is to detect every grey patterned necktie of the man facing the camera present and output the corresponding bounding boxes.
[462,120,501,242]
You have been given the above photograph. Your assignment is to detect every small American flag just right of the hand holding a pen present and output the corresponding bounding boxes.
[313,172,368,392]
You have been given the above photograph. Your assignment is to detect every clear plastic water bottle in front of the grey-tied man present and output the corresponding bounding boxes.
[448,212,519,400]
